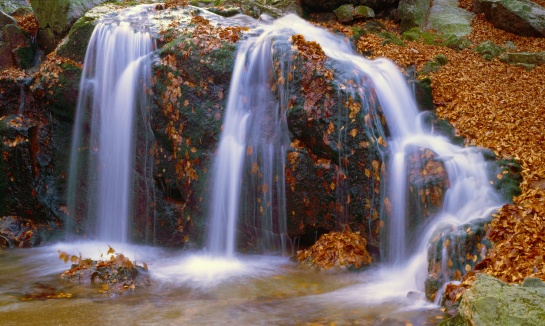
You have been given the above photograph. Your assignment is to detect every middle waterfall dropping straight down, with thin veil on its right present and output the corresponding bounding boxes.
[207,25,289,257]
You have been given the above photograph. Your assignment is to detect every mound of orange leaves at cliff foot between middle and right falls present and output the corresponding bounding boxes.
[296,230,373,271]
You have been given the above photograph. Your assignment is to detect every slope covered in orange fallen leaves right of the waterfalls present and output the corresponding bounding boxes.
[339,15,545,283]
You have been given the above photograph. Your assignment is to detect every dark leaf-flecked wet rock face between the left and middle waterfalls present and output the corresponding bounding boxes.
[151,16,240,245]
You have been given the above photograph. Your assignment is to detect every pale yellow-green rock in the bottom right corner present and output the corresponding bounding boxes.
[459,274,545,326]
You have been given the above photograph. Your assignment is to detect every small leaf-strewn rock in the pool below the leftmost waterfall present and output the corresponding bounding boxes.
[59,247,150,296]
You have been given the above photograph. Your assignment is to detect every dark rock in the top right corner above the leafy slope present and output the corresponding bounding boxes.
[475,0,545,37]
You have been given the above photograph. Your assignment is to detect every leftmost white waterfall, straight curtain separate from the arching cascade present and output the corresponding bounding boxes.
[68,6,155,242]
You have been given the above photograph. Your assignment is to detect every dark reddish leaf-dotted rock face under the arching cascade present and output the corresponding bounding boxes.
[284,36,387,248]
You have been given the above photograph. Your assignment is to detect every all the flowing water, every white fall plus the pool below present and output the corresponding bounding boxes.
[0,5,501,325]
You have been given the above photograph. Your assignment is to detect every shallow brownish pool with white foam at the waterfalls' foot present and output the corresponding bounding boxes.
[0,242,444,325]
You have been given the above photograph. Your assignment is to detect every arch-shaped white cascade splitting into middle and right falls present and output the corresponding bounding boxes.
[208,15,502,290]
